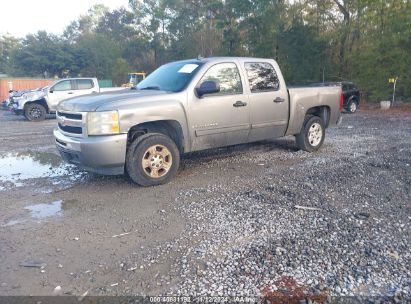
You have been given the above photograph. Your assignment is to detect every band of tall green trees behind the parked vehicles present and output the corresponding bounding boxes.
[0,0,411,101]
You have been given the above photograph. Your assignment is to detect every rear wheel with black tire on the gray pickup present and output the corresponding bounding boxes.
[295,115,325,152]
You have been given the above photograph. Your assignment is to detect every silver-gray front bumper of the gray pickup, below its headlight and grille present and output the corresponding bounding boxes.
[53,128,127,175]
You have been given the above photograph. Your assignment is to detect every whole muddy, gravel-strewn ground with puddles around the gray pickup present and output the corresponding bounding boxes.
[0,107,411,299]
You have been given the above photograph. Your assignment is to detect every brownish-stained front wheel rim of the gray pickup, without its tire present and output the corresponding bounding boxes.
[141,145,173,178]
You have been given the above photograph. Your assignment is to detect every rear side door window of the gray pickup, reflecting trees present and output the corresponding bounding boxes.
[245,62,280,93]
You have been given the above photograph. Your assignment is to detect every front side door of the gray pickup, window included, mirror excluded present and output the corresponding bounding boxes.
[190,62,250,151]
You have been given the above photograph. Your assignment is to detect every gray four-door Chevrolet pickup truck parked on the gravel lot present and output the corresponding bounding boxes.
[54,57,342,186]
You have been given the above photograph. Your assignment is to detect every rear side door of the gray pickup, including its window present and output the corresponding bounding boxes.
[244,61,289,142]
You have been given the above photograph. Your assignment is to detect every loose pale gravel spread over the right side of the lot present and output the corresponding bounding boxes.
[125,108,411,299]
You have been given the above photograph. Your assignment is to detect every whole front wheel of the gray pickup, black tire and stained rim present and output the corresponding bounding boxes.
[126,133,180,187]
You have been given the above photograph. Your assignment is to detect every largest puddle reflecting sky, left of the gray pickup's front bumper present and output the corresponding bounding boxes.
[0,151,73,187]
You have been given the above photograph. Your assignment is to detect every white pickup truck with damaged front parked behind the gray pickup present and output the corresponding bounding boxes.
[10,78,124,121]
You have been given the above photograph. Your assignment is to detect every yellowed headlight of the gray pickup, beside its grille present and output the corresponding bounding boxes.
[87,111,120,135]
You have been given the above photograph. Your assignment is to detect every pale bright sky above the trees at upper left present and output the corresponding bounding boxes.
[0,0,128,37]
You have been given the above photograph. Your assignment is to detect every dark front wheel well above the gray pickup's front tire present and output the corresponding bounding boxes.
[127,120,184,153]
